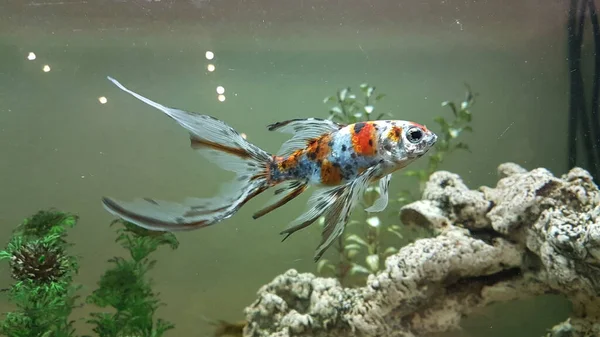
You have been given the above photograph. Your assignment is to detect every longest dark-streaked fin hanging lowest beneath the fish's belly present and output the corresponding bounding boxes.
[314,162,382,262]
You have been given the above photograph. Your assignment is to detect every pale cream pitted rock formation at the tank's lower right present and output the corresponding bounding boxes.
[244,163,600,337]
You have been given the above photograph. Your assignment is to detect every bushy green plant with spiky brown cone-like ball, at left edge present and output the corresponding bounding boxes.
[0,210,79,337]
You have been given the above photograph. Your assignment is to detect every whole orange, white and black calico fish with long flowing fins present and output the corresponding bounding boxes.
[102,76,437,262]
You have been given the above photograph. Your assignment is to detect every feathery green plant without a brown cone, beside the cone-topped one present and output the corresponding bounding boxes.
[87,220,179,337]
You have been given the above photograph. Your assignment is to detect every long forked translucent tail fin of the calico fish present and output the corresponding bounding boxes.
[102,77,273,231]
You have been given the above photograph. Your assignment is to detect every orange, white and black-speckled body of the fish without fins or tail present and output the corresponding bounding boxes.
[269,119,429,187]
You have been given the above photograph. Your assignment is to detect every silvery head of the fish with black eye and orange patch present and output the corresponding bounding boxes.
[382,121,438,166]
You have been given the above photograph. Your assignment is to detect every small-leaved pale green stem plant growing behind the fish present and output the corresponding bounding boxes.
[317,83,476,285]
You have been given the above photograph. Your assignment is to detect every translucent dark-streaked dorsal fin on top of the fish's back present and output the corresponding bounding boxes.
[267,118,345,156]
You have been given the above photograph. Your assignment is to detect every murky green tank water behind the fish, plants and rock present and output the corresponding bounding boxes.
[0,0,592,336]
